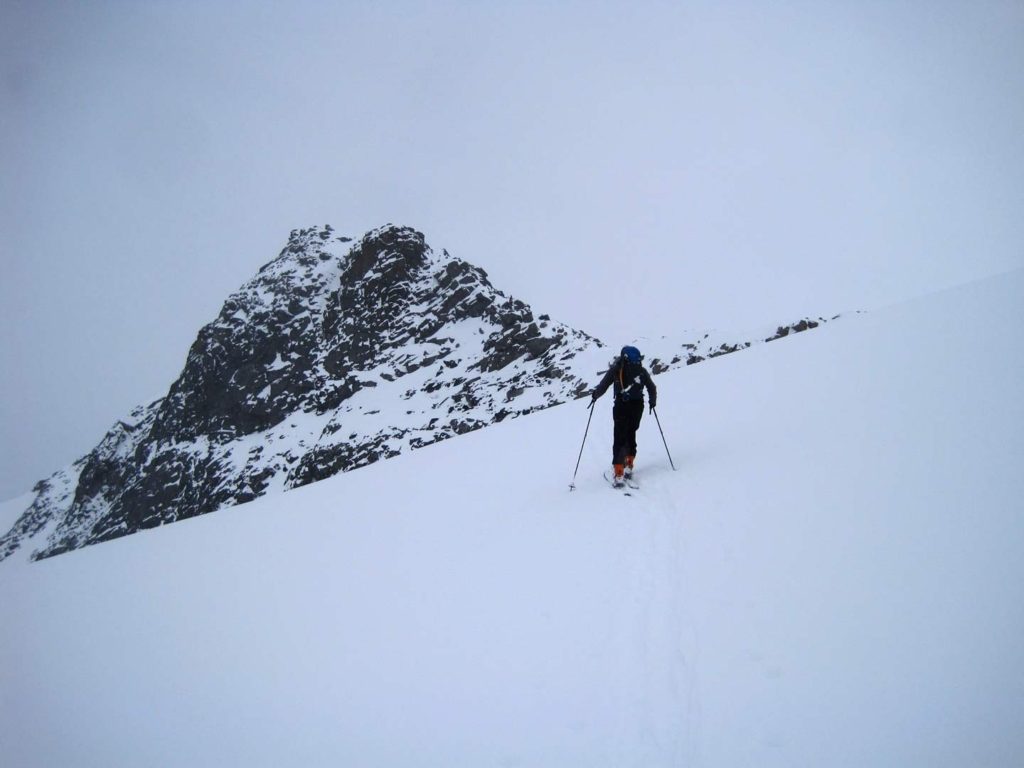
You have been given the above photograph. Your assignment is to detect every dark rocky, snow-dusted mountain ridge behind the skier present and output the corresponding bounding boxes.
[0,225,821,559]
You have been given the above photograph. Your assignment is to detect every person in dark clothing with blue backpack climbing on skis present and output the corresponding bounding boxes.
[590,346,657,487]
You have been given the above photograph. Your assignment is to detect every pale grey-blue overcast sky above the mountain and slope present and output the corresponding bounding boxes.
[0,0,1024,498]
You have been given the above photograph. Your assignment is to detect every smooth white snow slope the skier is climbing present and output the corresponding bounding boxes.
[0,272,1024,767]
